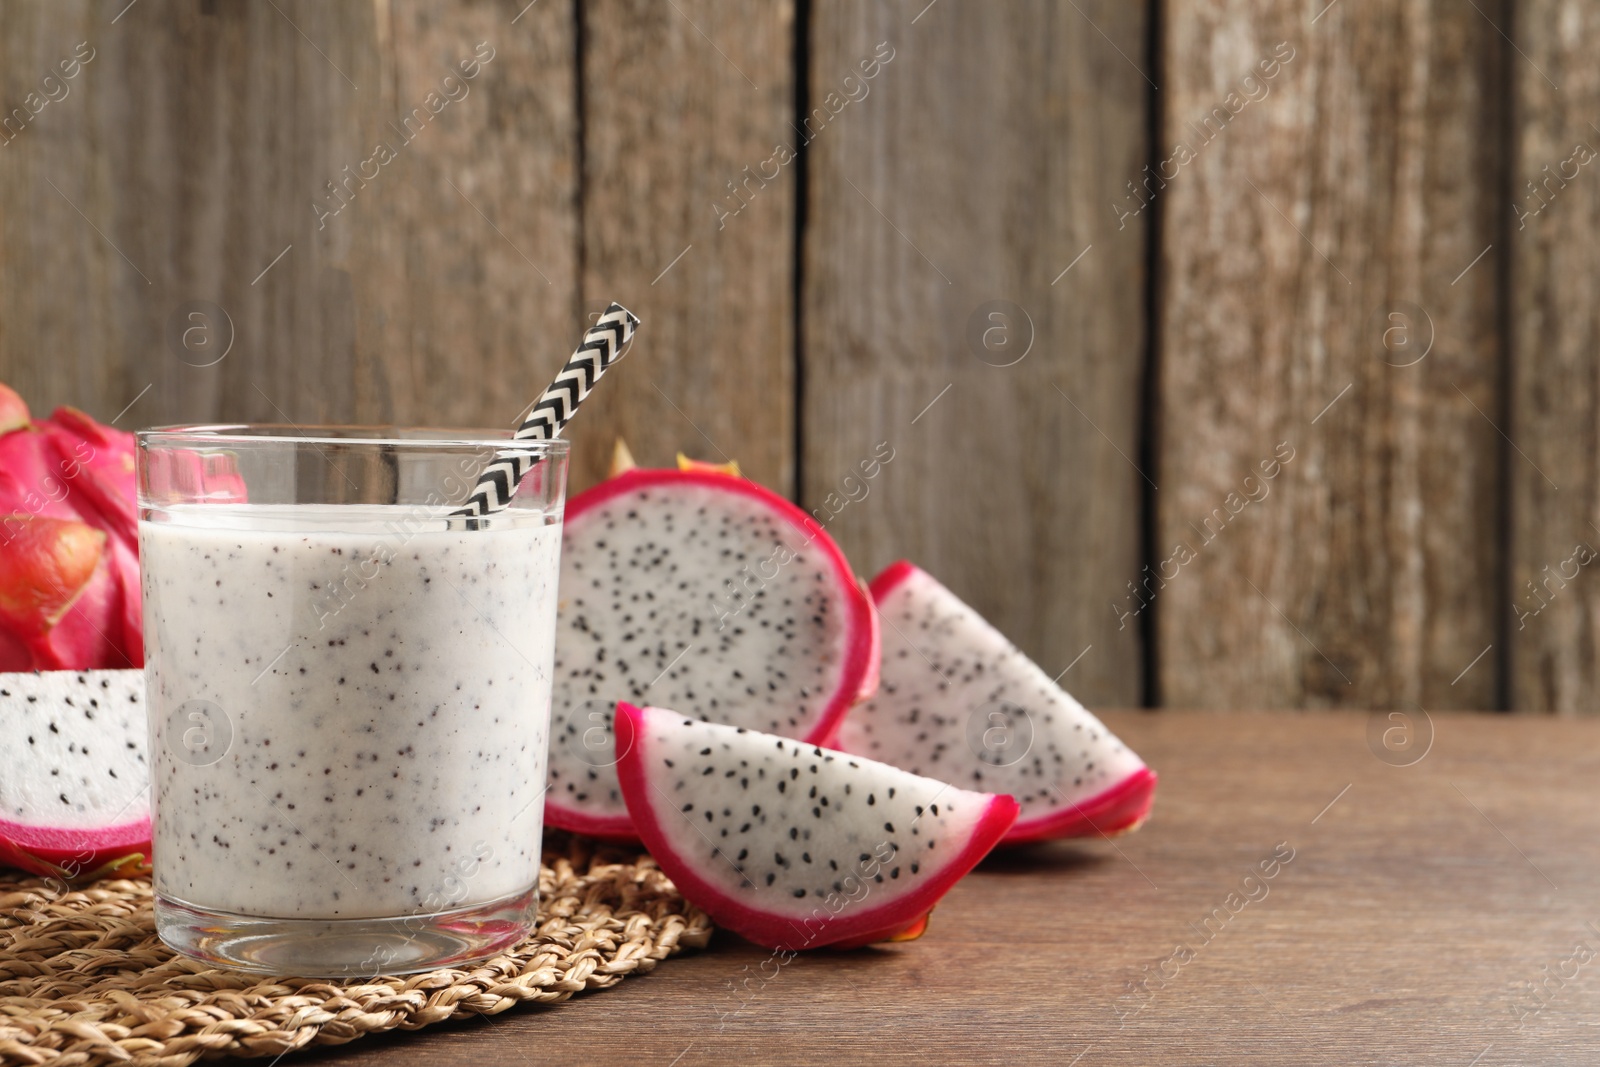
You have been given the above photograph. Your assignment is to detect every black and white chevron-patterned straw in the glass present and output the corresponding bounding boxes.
[451,302,638,518]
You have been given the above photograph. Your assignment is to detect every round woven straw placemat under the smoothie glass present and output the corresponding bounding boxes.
[0,833,712,1067]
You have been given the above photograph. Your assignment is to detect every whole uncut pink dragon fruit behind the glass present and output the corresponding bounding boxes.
[0,384,144,670]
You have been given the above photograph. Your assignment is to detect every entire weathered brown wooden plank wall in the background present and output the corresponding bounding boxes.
[0,0,1580,713]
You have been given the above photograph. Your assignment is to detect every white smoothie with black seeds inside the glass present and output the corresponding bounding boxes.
[139,506,562,918]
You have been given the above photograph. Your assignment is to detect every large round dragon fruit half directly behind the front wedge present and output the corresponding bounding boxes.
[546,466,878,838]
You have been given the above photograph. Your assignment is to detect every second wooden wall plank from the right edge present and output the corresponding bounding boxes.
[1157,0,1504,707]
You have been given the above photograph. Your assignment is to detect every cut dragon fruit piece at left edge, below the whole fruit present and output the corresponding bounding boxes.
[0,670,150,880]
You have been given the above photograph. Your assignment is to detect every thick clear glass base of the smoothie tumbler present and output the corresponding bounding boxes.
[155,888,539,977]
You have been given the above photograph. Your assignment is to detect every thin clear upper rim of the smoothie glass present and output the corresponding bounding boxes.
[133,422,571,456]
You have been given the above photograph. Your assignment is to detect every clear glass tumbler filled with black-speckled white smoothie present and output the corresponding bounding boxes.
[138,426,566,976]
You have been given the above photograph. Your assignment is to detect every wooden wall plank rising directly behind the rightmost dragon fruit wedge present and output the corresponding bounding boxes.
[802,0,1149,704]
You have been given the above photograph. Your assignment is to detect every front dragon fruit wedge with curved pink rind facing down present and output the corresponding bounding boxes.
[616,704,1018,952]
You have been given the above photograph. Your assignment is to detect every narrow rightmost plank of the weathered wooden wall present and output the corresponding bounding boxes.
[1506,0,1600,713]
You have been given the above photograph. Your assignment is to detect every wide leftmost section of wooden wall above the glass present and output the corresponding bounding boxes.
[0,3,578,426]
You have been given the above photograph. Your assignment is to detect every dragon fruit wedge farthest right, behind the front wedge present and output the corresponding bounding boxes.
[837,561,1157,845]
